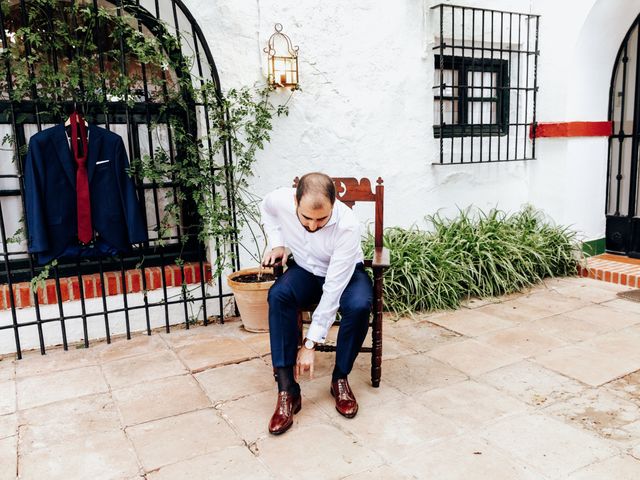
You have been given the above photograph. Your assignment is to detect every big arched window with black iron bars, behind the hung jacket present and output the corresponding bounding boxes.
[0,0,237,358]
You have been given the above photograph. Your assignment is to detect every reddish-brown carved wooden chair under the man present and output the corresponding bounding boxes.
[293,177,389,387]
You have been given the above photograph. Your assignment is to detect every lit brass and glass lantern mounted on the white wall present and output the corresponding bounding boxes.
[264,23,298,90]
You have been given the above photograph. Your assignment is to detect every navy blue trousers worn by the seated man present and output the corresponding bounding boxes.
[269,262,373,375]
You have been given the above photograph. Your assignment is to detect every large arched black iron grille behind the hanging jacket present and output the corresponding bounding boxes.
[0,0,238,358]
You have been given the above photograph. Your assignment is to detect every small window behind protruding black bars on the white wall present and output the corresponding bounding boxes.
[432,4,539,165]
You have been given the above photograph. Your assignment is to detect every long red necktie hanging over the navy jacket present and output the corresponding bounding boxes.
[69,112,93,243]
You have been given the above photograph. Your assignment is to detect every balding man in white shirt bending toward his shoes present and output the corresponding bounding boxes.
[260,173,373,435]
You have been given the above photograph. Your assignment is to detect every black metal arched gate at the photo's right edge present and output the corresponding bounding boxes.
[606,16,640,257]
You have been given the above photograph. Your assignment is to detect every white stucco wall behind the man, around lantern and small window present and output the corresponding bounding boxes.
[185,0,640,253]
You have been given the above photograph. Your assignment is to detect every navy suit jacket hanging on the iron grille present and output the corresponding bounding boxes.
[24,125,148,264]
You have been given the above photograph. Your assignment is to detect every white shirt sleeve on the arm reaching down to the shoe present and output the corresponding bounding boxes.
[307,224,362,343]
